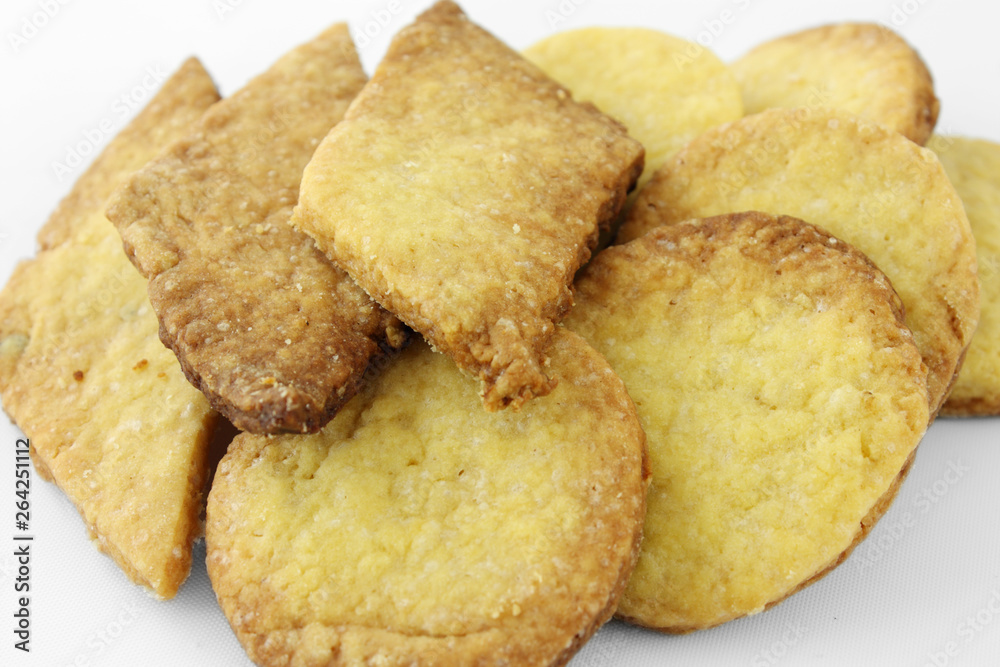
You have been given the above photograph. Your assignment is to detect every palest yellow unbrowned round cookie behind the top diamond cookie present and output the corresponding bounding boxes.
[524,28,743,187]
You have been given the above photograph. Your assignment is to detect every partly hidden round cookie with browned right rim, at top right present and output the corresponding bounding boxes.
[732,23,940,145]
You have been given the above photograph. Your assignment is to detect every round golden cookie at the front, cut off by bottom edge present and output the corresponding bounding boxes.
[206,327,649,666]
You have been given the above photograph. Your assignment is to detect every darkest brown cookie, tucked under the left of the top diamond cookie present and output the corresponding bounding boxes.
[108,24,406,433]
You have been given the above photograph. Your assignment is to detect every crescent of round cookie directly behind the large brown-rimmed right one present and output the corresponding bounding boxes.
[618,108,979,415]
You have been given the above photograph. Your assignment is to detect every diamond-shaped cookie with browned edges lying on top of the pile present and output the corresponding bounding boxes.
[292,1,643,410]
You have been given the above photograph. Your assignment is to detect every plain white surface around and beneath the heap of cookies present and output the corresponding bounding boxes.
[0,0,1000,667]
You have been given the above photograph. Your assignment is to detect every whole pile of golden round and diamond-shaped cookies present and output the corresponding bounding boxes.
[0,0,1000,665]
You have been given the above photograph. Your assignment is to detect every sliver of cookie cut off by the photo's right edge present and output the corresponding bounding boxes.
[927,136,1000,417]
